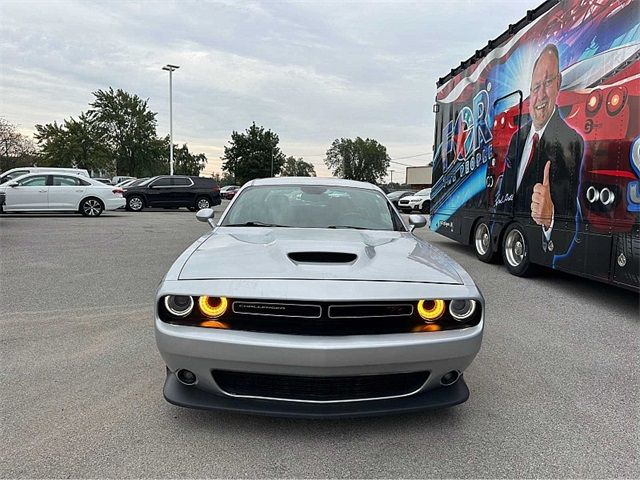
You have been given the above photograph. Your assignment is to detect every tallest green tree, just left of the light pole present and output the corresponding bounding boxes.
[88,87,162,177]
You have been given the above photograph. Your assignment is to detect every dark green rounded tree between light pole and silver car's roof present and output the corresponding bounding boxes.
[222,122,285,185]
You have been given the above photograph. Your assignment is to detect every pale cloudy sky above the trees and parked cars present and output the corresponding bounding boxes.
[0,0,542,181]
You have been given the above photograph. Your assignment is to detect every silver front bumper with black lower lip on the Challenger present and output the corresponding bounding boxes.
[155,317,483,417]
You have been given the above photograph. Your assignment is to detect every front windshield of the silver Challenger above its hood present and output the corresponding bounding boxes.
[221,185,400,230]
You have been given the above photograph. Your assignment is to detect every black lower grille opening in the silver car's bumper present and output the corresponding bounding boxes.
[212,370,429,402]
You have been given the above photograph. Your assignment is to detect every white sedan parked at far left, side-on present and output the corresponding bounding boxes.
[0,172,125,217]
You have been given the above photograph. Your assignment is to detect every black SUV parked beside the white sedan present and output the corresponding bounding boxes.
[124,175,220,212]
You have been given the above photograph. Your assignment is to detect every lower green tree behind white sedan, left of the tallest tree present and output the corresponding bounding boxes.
[35,113,115,174]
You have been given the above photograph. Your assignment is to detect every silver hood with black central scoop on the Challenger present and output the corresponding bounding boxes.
[179,227,464,284]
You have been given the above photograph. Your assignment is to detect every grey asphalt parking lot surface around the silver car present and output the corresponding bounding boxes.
[0,202,640,478]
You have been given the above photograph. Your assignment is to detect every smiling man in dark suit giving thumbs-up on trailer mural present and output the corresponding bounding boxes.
[501,44,584,265]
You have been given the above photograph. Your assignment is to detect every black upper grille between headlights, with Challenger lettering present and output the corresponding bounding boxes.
[224,300,424,336]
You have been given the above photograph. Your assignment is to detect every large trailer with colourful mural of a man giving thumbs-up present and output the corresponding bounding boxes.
[430,0,640,290]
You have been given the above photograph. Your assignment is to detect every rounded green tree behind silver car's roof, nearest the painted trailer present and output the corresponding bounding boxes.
[324,137,391,183]
